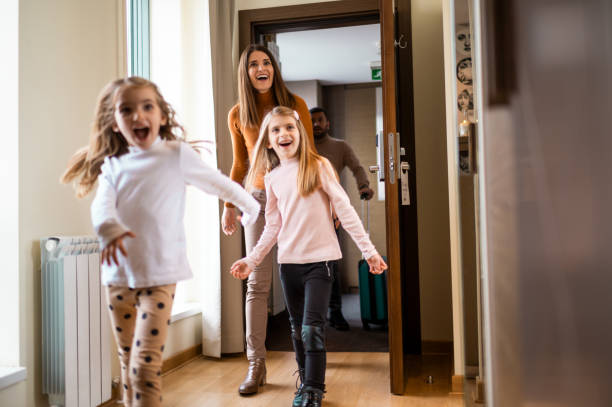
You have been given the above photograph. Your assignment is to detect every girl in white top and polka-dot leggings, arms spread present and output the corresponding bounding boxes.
[61,77,259,407]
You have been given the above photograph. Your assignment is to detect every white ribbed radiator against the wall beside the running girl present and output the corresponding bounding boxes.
[40,236,112,407]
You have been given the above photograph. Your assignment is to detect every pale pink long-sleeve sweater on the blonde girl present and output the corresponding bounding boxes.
[246,158,377,268]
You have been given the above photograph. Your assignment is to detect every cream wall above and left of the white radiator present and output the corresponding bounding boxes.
[0,0,124,407]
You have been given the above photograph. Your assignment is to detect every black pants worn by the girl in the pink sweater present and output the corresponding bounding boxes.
[279,261,333,390]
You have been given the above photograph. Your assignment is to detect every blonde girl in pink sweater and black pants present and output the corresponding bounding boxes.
[230,106,387,407]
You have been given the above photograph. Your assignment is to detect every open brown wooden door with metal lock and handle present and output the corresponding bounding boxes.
[379,0,421,394]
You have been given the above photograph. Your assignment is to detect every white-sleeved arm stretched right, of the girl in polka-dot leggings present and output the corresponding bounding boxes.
[179,142,260,226]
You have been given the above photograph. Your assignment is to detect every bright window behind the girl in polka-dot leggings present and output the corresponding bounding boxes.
[128,0,220,315]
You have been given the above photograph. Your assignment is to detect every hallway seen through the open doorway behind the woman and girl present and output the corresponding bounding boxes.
[263,24,389,352]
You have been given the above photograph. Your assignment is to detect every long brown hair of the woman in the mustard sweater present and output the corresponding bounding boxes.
[238,44,296,128]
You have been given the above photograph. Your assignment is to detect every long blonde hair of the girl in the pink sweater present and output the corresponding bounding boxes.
[246,106,324,196]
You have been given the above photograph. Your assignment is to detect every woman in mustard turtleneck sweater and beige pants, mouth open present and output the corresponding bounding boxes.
[221,44,314,395]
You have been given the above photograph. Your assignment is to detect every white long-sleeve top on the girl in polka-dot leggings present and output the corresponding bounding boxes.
[91,138,260,288]
